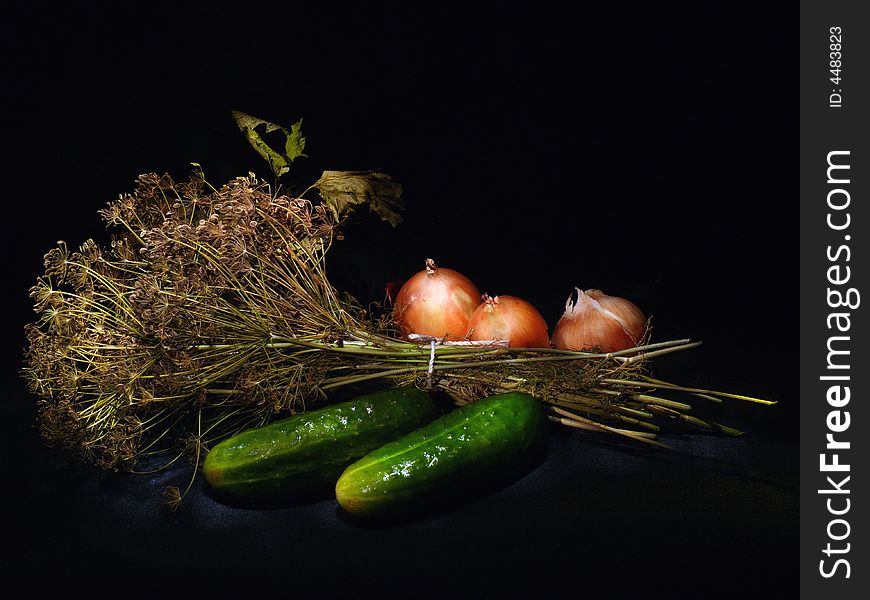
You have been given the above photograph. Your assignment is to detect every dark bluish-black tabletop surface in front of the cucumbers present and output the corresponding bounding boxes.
[3,366,799,598]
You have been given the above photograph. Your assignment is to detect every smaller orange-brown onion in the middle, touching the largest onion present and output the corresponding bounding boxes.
[466,294,550,348]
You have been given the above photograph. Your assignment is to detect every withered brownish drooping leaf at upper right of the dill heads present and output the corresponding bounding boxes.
[313,171,404,227]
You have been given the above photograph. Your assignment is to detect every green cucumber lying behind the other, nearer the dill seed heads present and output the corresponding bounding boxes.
[203,387,439,501]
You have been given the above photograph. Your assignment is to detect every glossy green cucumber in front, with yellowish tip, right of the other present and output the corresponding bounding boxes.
[335,392,547,517]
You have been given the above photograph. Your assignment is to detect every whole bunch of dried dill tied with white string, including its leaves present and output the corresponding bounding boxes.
[23,113,772,478]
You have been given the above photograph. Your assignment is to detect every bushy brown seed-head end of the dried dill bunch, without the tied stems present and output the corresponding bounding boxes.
[24,170,384,469]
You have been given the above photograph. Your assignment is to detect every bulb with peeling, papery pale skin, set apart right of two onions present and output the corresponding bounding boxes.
[553,288,647,352]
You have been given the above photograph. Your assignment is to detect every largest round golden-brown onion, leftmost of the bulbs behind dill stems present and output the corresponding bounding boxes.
[393,258,480,340]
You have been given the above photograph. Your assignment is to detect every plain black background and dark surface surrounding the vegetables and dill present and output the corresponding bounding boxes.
[0,3,799,597]
